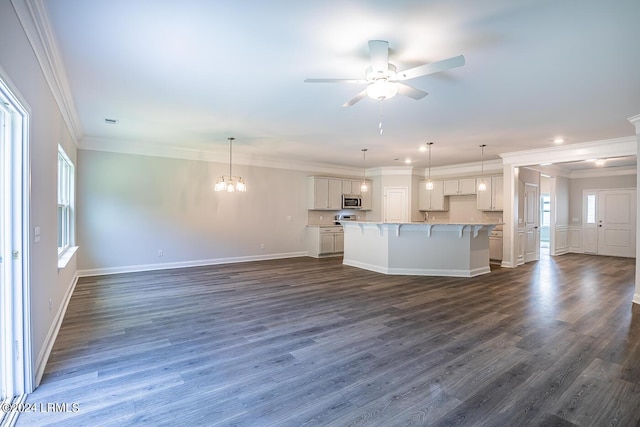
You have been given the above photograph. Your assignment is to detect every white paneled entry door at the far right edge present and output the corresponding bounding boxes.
[597,190,636,258]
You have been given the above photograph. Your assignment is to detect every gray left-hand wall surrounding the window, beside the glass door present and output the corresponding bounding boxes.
[0,1,76,382]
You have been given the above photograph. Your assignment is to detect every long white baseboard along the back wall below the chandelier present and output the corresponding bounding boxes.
[78,252,308,277]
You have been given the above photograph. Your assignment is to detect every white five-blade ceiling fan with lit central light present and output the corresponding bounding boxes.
[305,40,464,107]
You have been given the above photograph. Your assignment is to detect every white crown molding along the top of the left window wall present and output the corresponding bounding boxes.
[11,0,83,146]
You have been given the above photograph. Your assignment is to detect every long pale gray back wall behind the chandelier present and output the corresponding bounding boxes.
[77,150,309,273]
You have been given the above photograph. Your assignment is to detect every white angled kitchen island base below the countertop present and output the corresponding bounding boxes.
[342,221,496,277]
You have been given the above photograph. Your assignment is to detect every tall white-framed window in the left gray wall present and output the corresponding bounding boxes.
[58,146,74,256]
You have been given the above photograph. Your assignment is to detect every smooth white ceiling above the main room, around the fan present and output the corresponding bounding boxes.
[44,0,640,171]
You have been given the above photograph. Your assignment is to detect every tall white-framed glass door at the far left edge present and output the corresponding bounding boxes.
[0,67,34,399]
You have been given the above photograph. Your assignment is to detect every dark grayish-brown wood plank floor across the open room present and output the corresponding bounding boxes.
[18,254,640,426]
